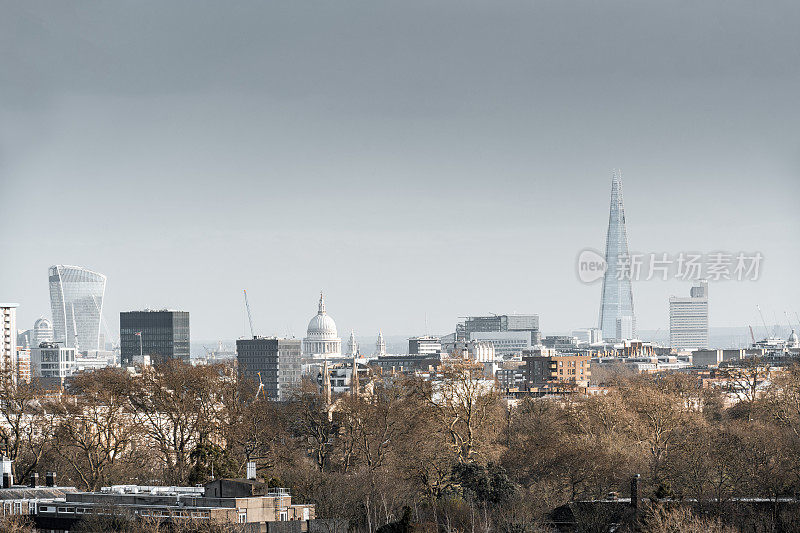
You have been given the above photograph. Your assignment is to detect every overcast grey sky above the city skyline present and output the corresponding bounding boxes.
[0,0,800,339]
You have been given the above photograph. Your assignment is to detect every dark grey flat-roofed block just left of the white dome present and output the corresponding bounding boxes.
[236,337,302,401]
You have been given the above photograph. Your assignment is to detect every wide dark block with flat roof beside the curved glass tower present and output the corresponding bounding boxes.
[119,309,190,365]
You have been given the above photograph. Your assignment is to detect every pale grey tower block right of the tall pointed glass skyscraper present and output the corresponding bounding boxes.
[669,280,708,350]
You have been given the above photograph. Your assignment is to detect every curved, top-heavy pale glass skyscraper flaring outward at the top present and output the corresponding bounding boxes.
[49,265,106,352]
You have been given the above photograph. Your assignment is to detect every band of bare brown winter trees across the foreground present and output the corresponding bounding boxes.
[0,362,800,533]
